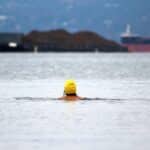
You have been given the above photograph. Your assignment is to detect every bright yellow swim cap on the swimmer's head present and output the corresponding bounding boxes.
[64,80,76,94]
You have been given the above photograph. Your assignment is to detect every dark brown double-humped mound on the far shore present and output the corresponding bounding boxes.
[23,29,127,52]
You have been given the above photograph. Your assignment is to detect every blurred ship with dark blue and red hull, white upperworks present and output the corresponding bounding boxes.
[121,25,150,52]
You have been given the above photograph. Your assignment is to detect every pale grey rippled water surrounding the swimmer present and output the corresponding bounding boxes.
[0,53,150,150]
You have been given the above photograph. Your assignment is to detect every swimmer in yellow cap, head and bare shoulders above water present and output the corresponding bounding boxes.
[59,80,85,101]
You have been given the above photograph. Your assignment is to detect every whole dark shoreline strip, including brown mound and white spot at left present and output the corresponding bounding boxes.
[0,29,128,53]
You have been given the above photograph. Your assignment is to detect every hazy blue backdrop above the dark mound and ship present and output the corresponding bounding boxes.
[0,0,150,41]
